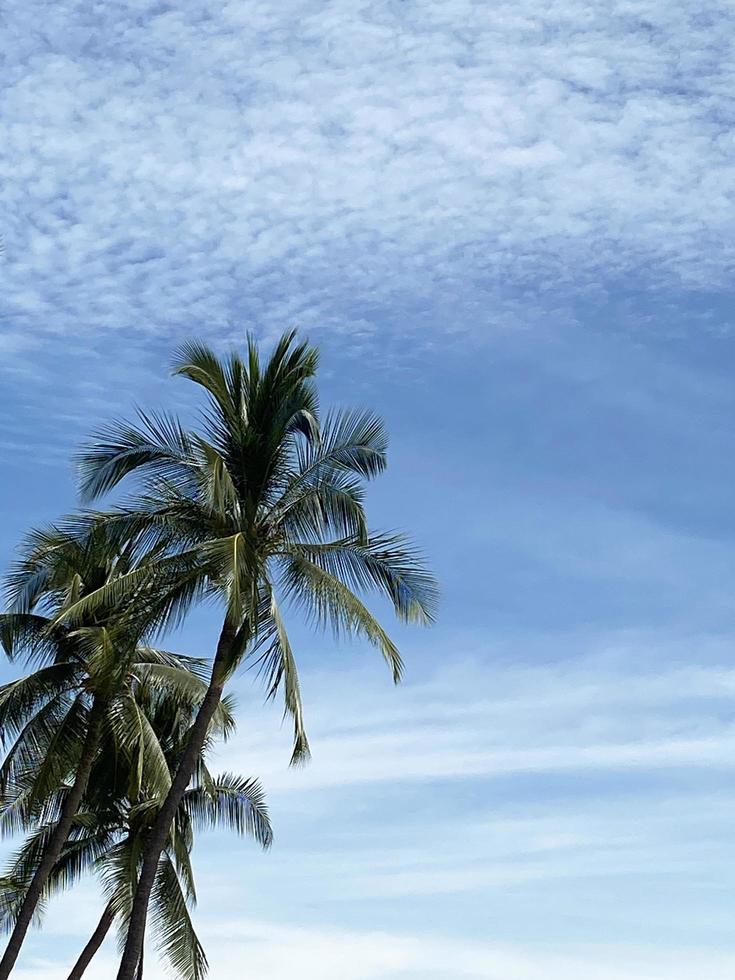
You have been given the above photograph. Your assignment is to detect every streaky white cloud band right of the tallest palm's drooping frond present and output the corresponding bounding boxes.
[214,639,735,793]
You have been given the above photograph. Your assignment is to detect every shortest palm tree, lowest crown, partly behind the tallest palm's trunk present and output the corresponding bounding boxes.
[0,683,272,980]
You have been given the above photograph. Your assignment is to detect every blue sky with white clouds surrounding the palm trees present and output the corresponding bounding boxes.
[0,0,735,980]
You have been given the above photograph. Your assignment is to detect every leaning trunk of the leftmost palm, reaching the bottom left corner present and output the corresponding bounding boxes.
[0,697,104,980]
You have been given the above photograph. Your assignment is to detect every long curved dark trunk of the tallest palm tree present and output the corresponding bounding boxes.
[116,622,237,980]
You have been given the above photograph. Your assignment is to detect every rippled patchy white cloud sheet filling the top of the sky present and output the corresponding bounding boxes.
[0,0,735,350]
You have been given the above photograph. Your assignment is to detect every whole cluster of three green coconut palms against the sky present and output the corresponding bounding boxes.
[0,333,436,980]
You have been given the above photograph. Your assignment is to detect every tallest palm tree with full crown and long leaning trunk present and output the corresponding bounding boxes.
[64,333,436,980]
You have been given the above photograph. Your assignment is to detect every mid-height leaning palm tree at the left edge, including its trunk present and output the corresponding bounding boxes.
[0,526,213,977]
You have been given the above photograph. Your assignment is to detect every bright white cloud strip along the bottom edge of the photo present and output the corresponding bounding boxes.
[16,920,735,980]
